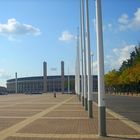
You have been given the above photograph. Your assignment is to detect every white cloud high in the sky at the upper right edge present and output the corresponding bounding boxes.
[118,8,140,31]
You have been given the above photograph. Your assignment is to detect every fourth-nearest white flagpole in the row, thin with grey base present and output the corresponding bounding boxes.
[80,0,84,106]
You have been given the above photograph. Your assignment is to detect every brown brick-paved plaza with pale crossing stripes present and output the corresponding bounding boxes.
[0,94,140,140]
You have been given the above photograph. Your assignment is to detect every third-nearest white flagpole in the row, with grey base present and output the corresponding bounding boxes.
[82,0,88,110]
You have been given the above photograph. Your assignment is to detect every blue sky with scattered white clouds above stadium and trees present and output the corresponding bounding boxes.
[0,0,140,86]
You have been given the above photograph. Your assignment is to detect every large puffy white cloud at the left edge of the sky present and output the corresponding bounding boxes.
[0,18,41,39]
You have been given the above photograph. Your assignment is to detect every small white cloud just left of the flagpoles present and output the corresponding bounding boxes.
[59,31,75,42]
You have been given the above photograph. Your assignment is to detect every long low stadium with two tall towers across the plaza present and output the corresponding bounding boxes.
[7,61,97,93]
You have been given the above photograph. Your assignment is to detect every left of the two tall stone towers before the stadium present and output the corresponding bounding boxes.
[43,61,47,93]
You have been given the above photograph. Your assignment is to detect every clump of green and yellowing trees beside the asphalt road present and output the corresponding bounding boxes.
[105,43,140,93]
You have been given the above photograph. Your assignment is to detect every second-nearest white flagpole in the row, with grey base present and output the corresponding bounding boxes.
[86,0,93,118]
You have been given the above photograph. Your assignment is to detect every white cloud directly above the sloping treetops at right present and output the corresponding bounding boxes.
[105,45,135,70]
